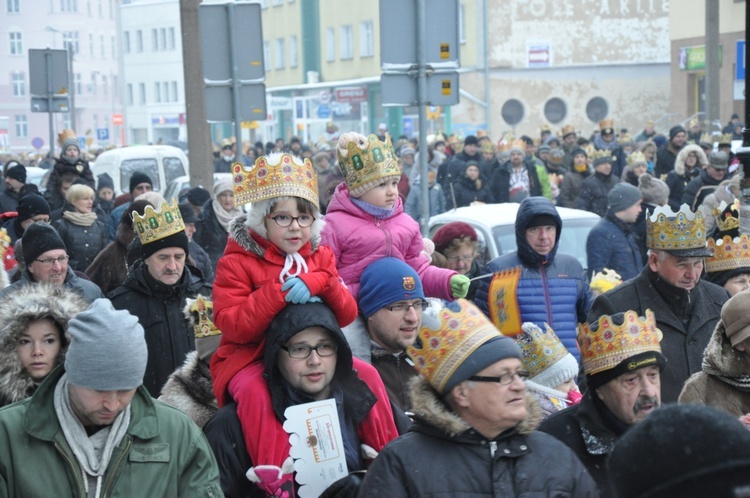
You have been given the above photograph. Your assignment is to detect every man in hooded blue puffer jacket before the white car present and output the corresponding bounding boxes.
[474,197,594,359]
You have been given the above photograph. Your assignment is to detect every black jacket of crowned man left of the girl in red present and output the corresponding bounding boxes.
[108,260,211,397]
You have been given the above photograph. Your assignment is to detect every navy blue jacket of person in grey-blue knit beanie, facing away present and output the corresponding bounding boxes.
[586,209,645,281]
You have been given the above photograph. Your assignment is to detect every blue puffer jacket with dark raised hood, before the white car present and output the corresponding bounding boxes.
[474,197,593,359]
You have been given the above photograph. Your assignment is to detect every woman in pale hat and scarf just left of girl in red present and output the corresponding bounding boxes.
[193,177,242,271]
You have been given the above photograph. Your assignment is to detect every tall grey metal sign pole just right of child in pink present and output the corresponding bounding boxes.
[417,0,430,236]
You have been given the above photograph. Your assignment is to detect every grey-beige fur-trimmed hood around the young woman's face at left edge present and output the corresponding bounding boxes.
[0,284,88,406]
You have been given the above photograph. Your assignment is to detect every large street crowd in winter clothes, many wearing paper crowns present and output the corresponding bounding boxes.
[0,112,750,498]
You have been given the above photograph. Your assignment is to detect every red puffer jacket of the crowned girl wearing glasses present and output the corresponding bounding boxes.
[211,216,357,406]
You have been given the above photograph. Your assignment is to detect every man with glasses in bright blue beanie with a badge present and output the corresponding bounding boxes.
[359,258,428,411]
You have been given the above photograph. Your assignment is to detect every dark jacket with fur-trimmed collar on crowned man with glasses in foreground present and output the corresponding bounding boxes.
[358,378,599,498]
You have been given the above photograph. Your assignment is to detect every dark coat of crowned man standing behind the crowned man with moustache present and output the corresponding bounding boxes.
[587,266,729,403]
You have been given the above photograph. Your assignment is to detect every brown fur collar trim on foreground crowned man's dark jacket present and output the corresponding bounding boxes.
[409,376,542,437]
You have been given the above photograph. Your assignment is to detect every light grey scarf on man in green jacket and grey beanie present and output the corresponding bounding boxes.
[54,374,130,498]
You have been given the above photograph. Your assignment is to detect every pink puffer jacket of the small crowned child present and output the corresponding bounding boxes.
[322,183,457,300]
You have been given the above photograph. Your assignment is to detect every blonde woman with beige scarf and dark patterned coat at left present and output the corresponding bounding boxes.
[53,185,109,272]
